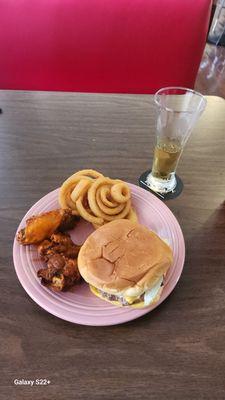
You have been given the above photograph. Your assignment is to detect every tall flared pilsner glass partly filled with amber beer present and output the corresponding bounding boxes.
[146,87,206,193]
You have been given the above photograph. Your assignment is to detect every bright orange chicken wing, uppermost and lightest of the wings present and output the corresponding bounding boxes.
[17,209,79,245]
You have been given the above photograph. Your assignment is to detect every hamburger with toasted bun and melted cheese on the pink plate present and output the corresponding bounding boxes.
[78,219,173,308]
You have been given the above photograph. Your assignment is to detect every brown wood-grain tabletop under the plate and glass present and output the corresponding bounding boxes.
[0,91,225,400]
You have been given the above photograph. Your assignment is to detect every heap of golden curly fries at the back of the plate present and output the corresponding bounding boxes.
[59,170,137,229]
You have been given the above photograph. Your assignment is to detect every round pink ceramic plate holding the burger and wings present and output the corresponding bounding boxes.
[13,184,185,326]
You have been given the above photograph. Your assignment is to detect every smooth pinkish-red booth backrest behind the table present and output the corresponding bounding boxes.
[0,0,211,93]
